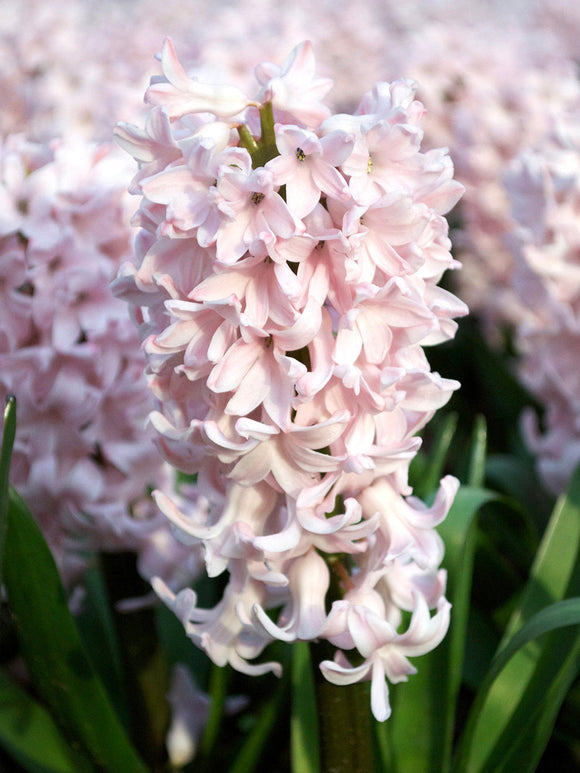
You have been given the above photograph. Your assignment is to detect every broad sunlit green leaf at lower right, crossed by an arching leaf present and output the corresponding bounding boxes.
[456,468,580,771]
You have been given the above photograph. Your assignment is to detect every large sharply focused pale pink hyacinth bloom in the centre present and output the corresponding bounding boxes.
[114,40,467,720]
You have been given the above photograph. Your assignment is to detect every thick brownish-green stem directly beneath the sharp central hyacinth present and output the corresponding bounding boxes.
[312,642,373,773]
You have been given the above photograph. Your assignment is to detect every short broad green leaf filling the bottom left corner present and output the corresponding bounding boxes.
[0,671,95,773]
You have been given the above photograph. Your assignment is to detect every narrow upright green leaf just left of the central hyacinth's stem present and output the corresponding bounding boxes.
[290,642,320,773]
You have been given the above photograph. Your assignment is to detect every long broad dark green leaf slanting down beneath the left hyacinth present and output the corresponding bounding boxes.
[4,489,146,773]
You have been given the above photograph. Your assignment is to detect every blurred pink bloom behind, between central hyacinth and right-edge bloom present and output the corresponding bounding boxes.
[390,17,580,337]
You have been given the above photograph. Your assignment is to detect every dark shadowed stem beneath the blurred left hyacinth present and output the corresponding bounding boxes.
[101,553,170,773]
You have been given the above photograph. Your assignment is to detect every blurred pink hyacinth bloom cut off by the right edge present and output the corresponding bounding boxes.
[506,112,580,494]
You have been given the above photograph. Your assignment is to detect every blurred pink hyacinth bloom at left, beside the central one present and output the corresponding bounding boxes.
[0,136,199,586]
